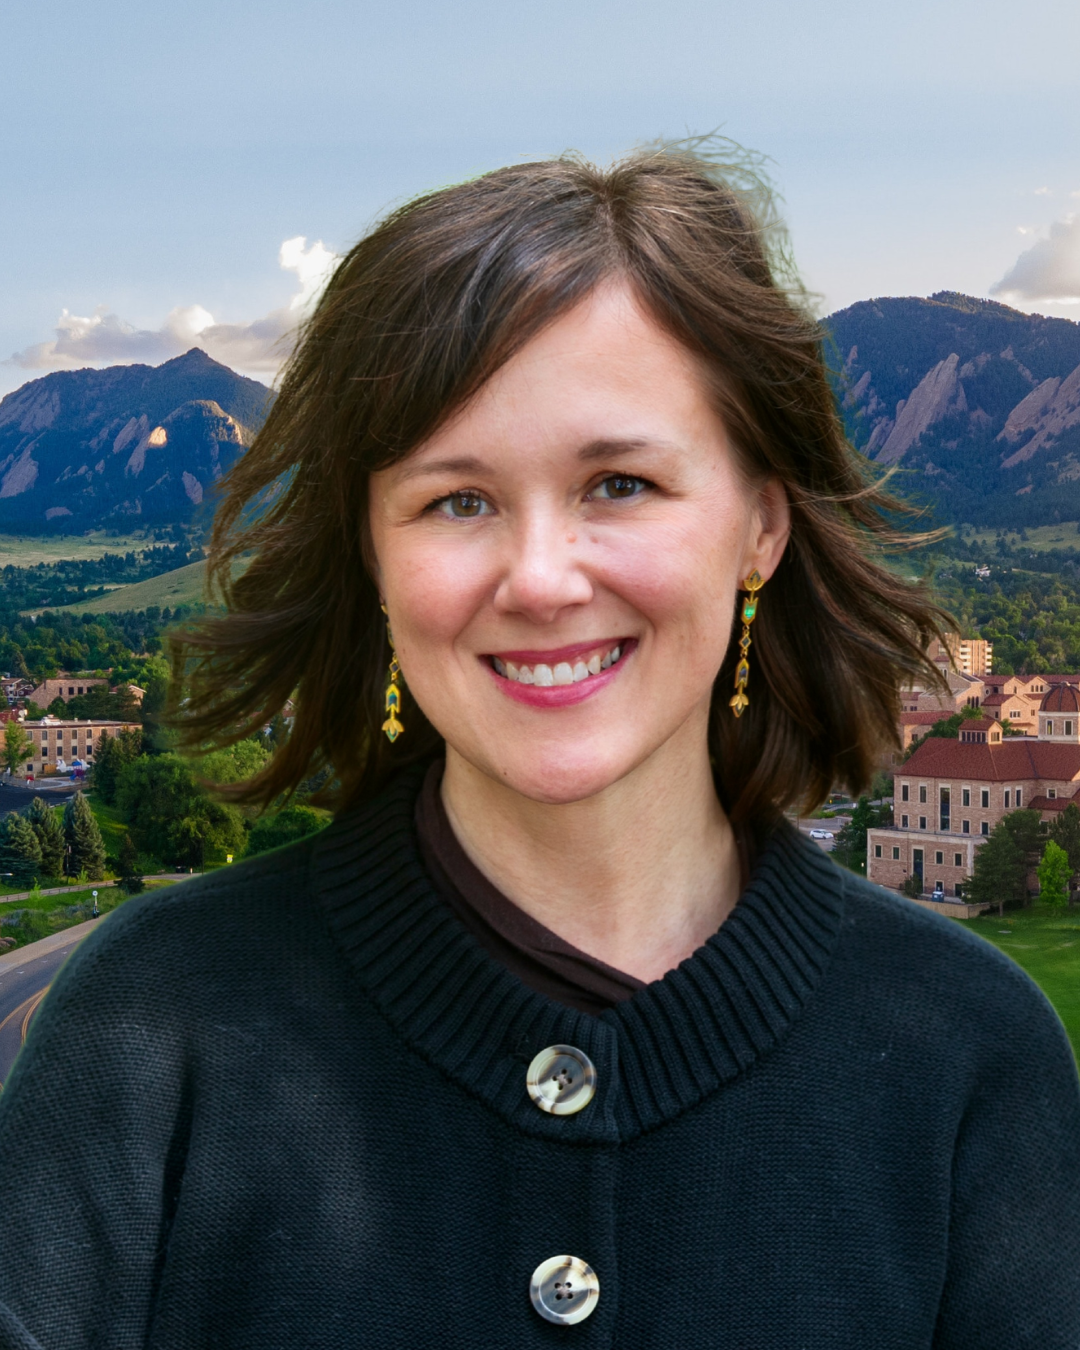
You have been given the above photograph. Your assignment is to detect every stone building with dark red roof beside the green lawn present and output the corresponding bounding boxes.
[867,684,1080,895]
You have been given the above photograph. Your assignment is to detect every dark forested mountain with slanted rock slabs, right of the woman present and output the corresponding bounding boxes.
[825,290,1080,527]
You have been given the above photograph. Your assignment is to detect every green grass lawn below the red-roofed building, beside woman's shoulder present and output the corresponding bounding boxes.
[953,905,1080,1060]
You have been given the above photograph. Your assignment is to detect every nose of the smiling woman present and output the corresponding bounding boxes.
[495,513,593,624]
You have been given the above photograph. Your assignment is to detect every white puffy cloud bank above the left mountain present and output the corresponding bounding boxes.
[4,235,339,378]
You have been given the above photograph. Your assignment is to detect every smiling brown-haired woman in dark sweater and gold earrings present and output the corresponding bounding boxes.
[0,155,1080,1350]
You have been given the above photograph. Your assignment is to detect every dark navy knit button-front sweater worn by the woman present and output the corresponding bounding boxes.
[0,772,1080,1350]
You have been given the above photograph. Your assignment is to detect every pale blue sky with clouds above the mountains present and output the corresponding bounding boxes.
[0,0,1080,394]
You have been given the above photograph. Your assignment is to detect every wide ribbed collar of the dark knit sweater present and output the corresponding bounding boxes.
[313,765,844,1142]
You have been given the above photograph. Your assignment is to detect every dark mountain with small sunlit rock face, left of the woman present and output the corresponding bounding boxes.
[0,347,273,533]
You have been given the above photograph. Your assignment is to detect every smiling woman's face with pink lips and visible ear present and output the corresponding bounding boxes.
[371,285,788,803]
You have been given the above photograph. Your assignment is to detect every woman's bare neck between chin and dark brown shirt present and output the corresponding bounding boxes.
[443,733,738,981]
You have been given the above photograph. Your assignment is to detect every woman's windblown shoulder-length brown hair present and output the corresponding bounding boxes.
[173,150,945,819]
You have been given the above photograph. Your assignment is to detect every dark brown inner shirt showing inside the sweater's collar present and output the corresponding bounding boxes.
[416,760,751,1014]
